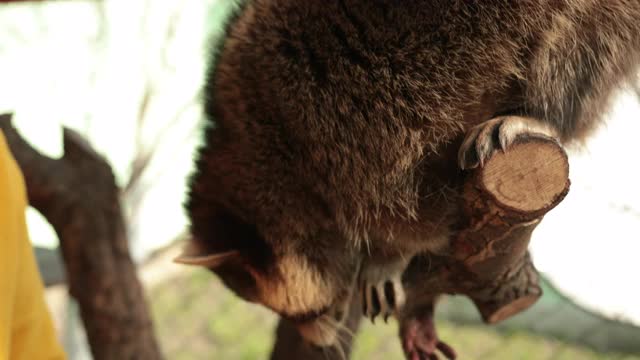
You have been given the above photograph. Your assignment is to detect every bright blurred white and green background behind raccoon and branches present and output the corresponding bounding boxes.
[0,0,640,360]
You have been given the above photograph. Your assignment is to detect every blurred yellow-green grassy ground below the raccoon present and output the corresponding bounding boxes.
[150,269,640,360]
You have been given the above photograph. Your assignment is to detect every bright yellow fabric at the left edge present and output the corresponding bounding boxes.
[0,131,66,360]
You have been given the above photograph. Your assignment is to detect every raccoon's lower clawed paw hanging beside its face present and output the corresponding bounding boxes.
[359,260,408,322]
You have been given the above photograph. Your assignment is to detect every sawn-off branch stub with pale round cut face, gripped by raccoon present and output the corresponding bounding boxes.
[454,137,570,324]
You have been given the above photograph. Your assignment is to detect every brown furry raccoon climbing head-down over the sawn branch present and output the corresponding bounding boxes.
[176,0,640,346]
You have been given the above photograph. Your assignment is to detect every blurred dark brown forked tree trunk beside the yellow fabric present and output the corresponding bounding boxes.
[0,115,161,359]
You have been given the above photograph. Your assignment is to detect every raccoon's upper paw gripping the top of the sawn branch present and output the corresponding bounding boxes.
[458,116,557,169]
